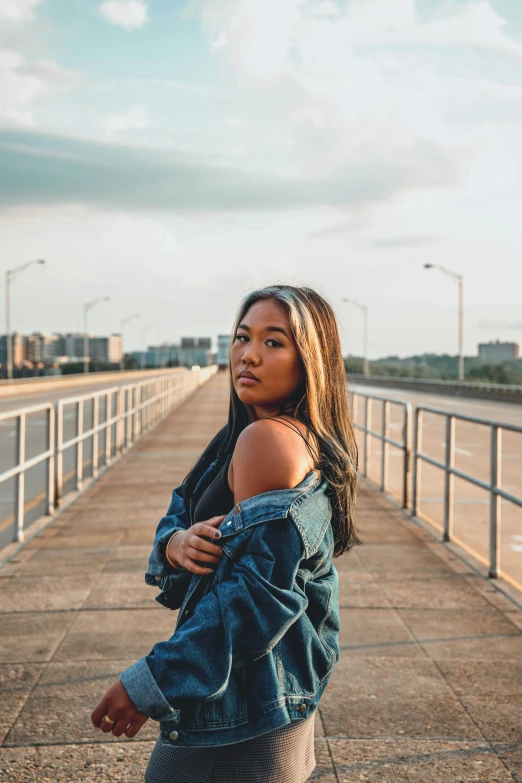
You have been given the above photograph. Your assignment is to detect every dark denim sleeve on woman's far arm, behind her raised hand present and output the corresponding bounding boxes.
[145,484,193,609]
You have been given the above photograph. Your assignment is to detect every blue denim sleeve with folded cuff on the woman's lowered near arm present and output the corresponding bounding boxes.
[120,519,308,720]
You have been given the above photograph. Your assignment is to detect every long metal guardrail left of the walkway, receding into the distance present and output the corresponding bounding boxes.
[0,365,217,542]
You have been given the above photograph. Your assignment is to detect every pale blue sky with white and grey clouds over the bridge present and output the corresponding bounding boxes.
[0,0,522,358]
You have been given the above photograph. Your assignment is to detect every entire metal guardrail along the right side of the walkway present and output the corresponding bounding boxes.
[350,391,522,589]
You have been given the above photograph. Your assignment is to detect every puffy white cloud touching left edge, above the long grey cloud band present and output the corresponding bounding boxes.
[0,49,78,126]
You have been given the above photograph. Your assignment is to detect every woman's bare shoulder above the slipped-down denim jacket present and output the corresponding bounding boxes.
[229,419,312,503]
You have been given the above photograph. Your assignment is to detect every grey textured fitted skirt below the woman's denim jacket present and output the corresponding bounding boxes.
[145,713,316,783]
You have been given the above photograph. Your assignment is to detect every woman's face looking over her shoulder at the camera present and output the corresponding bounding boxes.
[230,299,304,418]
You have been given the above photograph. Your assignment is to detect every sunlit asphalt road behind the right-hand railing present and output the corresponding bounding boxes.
[352,386,522,588]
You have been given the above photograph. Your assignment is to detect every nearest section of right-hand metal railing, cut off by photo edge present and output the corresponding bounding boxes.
[411,405,522,578]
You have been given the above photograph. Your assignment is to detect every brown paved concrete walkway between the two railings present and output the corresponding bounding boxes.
[0,374,522,783]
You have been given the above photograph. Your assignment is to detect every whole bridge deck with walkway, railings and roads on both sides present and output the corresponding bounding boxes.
[0,371,522,783]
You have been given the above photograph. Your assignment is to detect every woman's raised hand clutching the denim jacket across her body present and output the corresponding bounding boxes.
[167,514,226,574]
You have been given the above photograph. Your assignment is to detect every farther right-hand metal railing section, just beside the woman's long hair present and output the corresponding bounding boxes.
[350,392,412,508]
